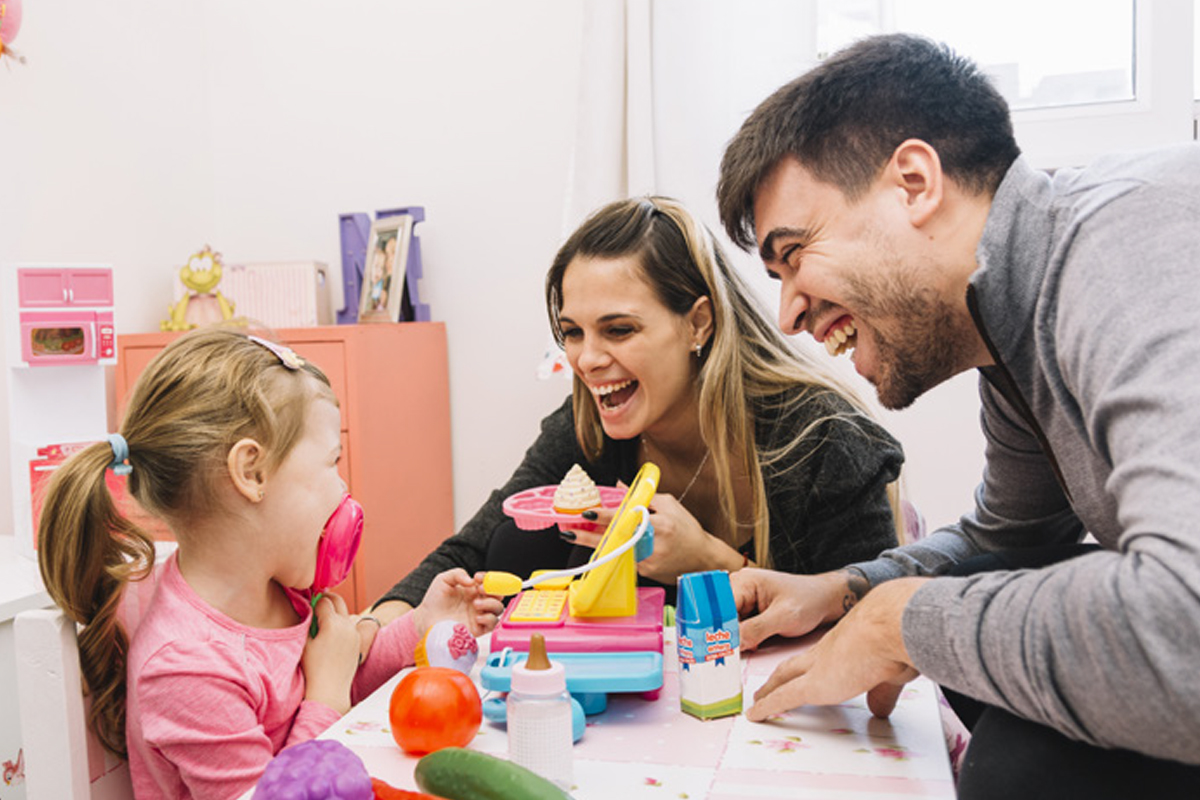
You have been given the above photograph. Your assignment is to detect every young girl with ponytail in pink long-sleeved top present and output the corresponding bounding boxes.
[38,330,499,800]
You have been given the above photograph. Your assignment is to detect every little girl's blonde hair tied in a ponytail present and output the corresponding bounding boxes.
[37,329,337,757]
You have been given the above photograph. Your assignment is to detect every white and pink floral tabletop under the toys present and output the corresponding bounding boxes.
[324,631,954,800]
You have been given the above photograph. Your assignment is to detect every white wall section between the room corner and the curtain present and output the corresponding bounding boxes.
[199,0,582,533]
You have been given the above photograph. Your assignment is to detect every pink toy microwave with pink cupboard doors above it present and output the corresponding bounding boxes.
[17,267,116,367]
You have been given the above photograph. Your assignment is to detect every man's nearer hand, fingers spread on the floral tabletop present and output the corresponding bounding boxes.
[734,573,929,722]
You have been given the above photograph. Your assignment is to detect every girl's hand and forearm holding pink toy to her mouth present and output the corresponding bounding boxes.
[300,593,359,714]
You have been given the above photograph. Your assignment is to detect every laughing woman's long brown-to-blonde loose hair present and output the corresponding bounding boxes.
[546,197,901,566]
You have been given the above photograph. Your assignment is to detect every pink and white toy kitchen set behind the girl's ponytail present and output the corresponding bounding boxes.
[0,264,116,558]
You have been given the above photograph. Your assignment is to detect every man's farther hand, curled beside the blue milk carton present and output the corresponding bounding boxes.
[730,569,865,650]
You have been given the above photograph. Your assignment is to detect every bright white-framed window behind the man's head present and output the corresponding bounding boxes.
[816,0,1200,168]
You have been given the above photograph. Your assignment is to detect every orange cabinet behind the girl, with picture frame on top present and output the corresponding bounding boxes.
[116,323,454,612]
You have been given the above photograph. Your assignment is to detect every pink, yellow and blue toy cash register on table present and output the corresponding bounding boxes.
[480,463,665,714]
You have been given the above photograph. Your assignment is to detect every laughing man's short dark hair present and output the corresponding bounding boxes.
[716,34,1020,249]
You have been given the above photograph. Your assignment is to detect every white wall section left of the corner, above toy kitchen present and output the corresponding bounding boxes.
[0,0,212,544]
